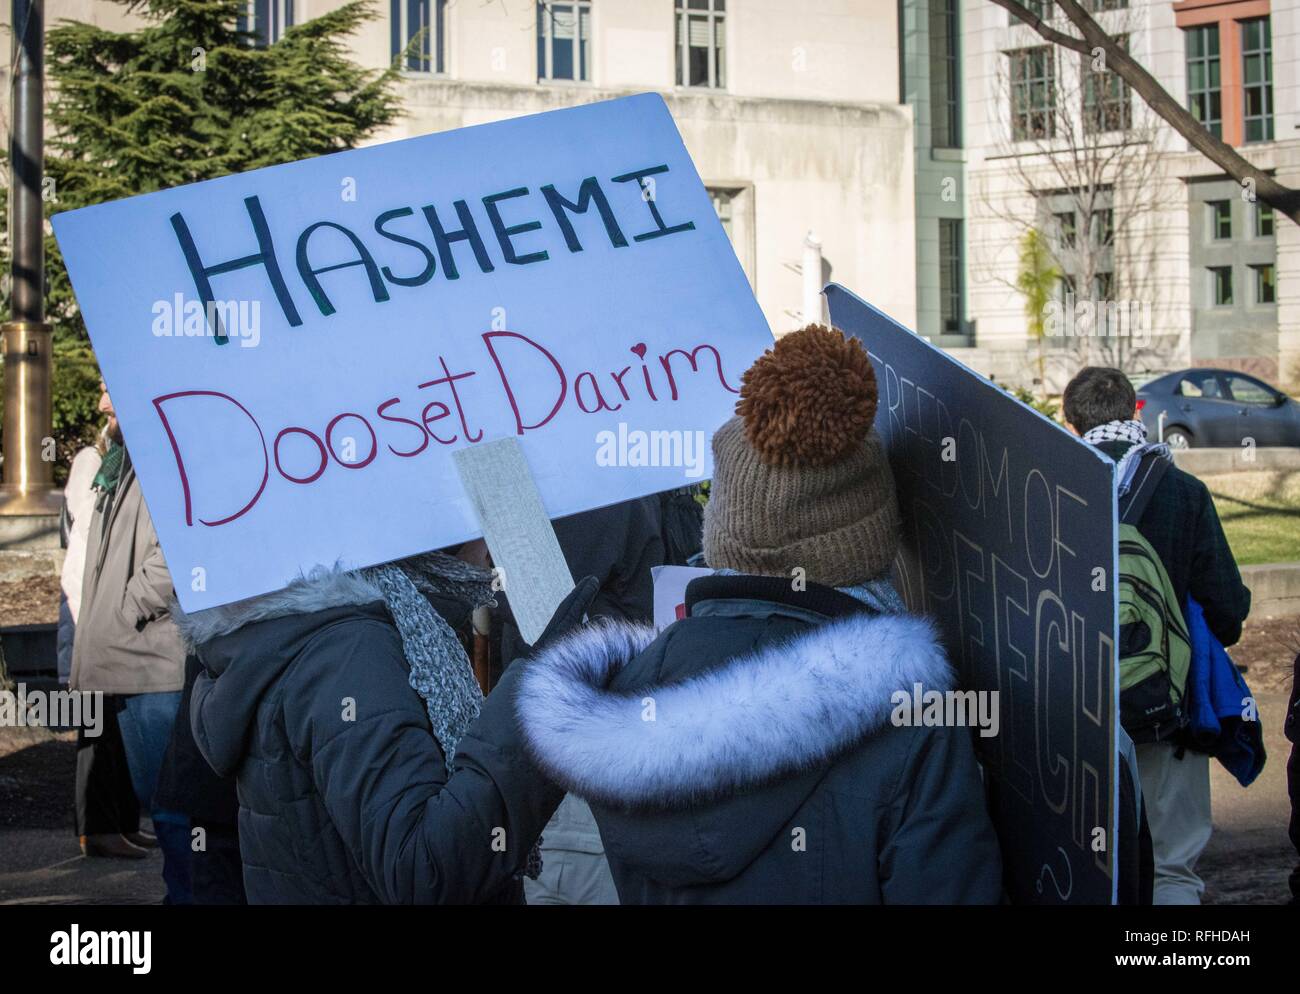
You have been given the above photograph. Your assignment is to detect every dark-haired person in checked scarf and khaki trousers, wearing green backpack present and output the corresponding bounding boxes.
[1062,366,1251,904]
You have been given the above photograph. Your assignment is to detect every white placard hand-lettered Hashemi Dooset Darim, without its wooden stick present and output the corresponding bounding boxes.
[53,95,771,611]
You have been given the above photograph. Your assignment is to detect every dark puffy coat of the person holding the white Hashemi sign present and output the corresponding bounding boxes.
[178,573,560,904]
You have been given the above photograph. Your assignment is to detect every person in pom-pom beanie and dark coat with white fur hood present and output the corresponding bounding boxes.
[515,325,1002,904]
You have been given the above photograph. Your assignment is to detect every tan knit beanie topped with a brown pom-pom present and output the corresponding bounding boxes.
[705,325,900,587]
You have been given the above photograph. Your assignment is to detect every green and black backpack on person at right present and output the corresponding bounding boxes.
[1119,453,1192,742]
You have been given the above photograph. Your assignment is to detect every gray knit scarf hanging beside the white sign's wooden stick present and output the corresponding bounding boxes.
[361,552,493,776]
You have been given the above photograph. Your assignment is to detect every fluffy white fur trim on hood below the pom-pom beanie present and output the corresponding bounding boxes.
[516,615,953,807]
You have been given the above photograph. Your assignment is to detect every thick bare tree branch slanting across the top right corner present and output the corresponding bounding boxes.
[992,0,1300,225]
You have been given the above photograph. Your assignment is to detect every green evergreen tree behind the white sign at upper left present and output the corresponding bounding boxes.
[0,0,399,470]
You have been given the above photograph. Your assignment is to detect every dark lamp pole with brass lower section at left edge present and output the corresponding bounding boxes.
[0,0,59,516]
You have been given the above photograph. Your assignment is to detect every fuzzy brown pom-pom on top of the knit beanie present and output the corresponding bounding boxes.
[736,325,878,466]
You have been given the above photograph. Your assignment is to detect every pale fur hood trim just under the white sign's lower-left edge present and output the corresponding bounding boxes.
[172,567,384,650]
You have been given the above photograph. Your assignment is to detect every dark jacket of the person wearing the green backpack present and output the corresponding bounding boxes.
[1097,442,1251,646]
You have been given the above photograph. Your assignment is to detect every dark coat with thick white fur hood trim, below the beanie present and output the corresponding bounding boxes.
[517,576,1001,904]
